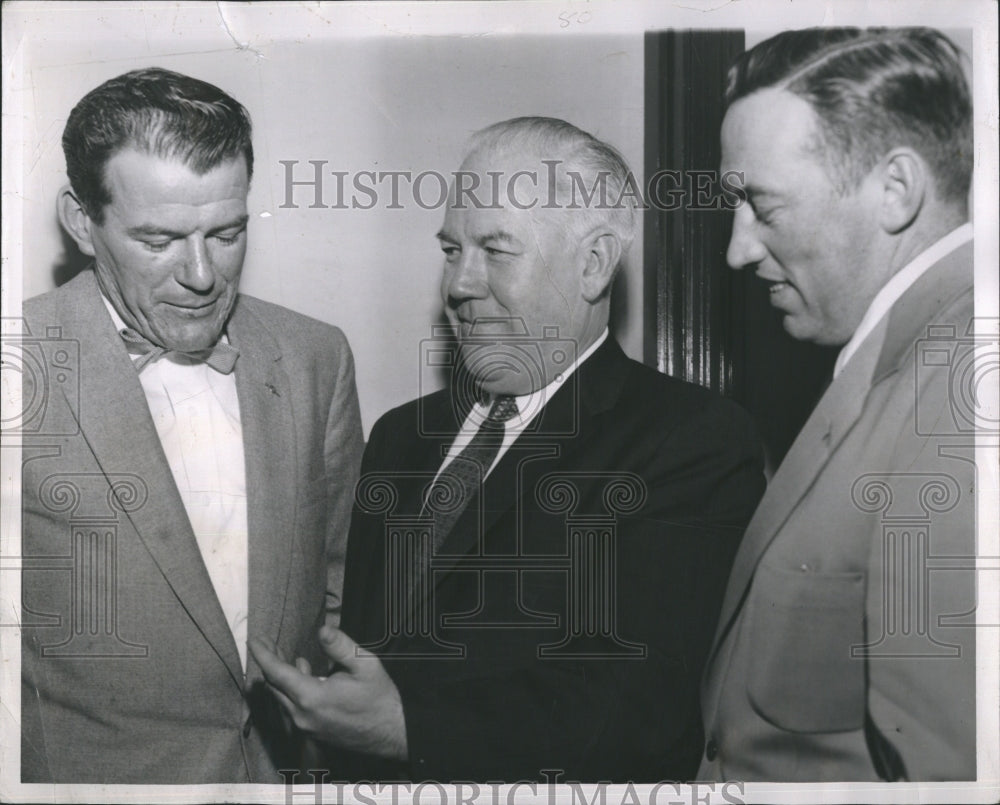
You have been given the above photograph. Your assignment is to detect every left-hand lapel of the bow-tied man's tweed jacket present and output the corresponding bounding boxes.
[62,271,243,686]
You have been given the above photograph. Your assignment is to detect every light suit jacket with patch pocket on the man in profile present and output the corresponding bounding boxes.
[699,244,972,782]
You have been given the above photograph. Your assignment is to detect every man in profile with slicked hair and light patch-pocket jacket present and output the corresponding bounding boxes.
[699,28,976,781]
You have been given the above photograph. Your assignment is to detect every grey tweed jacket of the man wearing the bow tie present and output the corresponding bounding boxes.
[21,271,362,783]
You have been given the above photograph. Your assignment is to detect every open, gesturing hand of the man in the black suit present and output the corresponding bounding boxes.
[250,626,407,760]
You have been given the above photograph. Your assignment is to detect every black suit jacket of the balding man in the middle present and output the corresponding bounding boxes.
[334,338,764,781]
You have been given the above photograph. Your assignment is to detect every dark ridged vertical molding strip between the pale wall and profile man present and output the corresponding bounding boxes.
[643,31,744,395]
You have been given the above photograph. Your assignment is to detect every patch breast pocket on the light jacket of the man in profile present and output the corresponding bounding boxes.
[747,564,865,733]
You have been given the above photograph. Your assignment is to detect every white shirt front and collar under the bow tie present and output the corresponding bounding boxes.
[104,299,250,670]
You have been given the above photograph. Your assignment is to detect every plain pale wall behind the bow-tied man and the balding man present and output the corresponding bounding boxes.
[23,31,643,432]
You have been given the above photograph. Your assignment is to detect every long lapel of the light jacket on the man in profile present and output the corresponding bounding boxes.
[710,243,972,656]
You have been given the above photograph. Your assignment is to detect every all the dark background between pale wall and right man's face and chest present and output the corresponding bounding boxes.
[643,31,837,469]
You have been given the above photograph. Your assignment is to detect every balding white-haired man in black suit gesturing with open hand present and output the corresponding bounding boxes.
[253,118,764,781]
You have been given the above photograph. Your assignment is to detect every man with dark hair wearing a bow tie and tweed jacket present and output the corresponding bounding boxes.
[21,68,362,783]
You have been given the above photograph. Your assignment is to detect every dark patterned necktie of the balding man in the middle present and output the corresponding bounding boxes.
[427,395,517,553]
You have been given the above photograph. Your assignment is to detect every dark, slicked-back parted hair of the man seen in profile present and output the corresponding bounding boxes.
[726,28,973,202]
